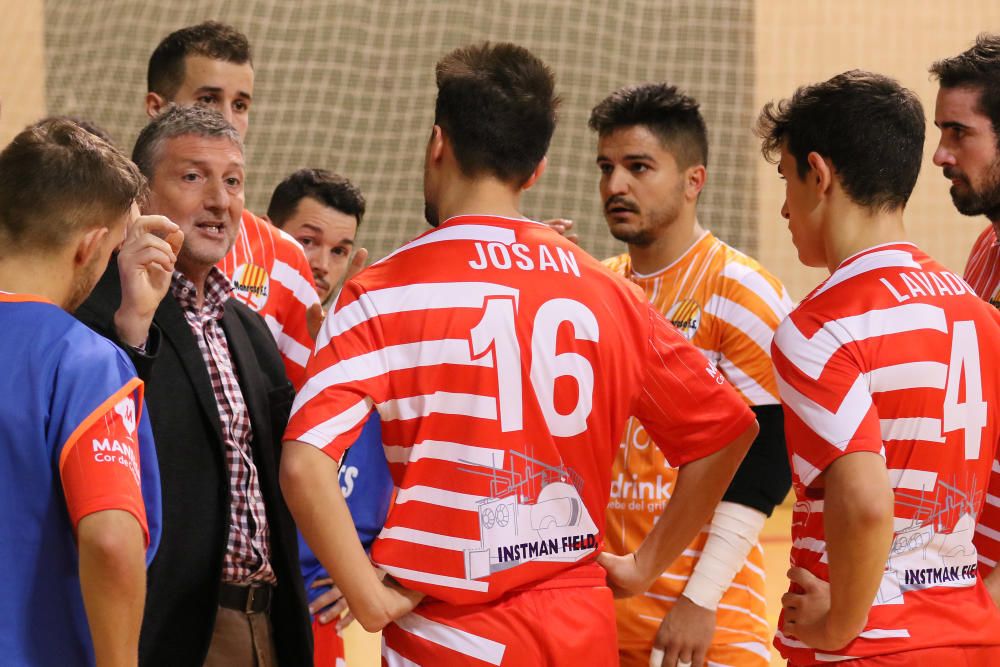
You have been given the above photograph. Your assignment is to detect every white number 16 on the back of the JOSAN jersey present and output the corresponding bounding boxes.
[469,297,599,438]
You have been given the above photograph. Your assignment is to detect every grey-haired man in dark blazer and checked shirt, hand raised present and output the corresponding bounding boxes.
[76,102,312,667]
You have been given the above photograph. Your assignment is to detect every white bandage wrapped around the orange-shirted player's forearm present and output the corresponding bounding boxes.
[684,501,767,611]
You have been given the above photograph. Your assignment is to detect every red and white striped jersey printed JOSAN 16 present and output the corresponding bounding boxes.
[285,216,753,604]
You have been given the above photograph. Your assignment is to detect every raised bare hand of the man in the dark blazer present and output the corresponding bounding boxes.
[115,215,184,347]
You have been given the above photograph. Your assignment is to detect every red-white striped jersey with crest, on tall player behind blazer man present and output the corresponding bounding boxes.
[218,210,319,389]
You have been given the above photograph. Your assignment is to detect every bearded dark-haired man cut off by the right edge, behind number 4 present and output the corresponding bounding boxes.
[930,34,1000,604]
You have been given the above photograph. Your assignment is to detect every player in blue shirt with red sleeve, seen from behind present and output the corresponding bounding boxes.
[0,119,165,665]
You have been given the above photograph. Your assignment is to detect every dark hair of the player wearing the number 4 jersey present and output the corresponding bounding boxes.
[754,70,925,211]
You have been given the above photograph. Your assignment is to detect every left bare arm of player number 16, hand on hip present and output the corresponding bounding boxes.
[281,440,424,632]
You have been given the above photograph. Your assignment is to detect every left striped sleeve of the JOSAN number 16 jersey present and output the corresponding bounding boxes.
[285,282,387,461]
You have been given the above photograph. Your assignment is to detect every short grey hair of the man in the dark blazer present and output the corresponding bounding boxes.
[132,104,243,180]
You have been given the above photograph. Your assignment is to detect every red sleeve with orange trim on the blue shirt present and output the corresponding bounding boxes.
[59,378,149,546]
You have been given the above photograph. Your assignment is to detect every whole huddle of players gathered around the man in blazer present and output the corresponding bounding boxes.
[0,22,1000,667]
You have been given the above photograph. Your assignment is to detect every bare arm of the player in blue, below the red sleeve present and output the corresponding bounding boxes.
[77,510,146,667]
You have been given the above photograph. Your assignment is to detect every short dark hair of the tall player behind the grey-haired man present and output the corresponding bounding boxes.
[146,21,253,100]
